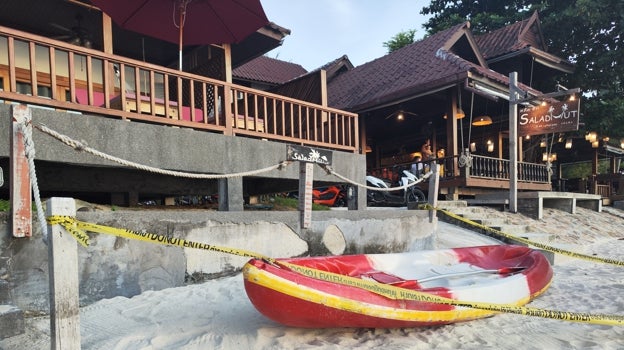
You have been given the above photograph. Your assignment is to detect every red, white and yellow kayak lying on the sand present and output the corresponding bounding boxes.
[243,245,553,328]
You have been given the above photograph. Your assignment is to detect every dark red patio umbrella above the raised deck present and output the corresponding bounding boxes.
[91,0,269,70]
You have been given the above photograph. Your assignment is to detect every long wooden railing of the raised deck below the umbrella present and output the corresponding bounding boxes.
[0,26,360,152]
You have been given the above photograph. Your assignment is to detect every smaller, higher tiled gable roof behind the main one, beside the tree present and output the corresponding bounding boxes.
[475,12,546,59]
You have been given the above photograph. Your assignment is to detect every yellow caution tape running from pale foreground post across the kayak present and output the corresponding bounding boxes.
[47,215,624,326]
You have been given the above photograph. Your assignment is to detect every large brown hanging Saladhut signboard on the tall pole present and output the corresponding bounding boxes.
[518,98,580,136]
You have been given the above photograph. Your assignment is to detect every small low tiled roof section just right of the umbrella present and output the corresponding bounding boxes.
[232,56,307,84]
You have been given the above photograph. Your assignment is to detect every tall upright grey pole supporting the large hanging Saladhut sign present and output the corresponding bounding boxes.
[509,72,518,213]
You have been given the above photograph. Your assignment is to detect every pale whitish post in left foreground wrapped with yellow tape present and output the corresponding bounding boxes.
[46,197,80,350]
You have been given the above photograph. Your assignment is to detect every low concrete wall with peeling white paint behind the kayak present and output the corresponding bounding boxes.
[0,208,435,312]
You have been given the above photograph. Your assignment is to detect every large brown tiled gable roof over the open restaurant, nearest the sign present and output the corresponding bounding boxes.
[327,22,508,112]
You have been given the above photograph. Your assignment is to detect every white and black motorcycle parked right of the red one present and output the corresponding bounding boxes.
[366,170,427,206]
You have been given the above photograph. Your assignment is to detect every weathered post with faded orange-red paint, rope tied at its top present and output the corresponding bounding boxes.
[9,105,32,237]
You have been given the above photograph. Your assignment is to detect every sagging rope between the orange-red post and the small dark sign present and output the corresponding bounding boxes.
[35,124,292,179]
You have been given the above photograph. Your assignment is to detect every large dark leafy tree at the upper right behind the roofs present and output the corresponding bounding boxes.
[421,0,624,137]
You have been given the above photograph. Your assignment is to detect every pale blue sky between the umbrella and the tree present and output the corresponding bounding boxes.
[261,0,429,71]
